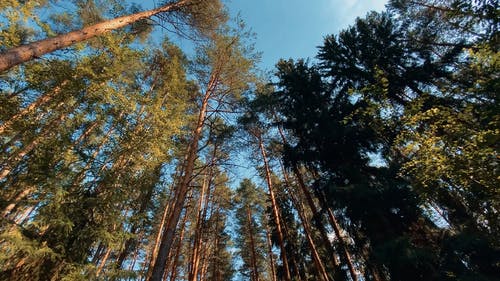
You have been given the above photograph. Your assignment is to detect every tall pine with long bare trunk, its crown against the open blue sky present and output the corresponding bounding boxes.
[149,20,254,280]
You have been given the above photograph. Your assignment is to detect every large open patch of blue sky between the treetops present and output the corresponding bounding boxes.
[224,0,387,70]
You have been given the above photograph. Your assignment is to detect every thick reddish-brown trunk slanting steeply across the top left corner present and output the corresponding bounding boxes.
[0,0,190,73]
